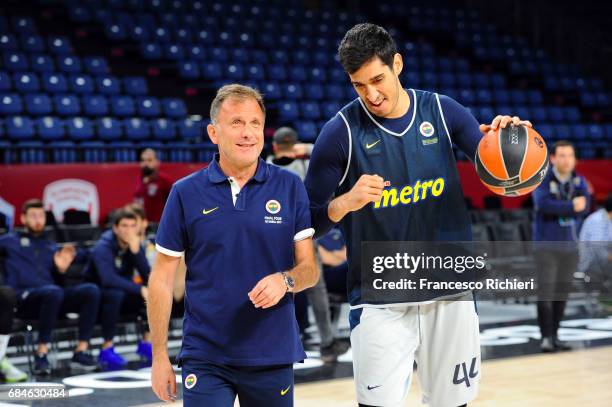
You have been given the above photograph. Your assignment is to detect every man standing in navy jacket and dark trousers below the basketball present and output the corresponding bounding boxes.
[533,140,589,352]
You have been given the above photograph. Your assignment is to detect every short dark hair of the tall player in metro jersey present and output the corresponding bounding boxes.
[338,23,397,74]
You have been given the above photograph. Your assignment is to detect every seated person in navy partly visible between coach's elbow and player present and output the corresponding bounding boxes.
[317,228,348,299]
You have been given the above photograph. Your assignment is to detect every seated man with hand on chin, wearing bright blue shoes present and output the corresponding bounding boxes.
[86,209,152,370]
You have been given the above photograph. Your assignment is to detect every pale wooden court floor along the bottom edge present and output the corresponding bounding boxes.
[143,346,612,407]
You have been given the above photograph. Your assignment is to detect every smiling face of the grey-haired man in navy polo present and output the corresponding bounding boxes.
[207,97,265,172]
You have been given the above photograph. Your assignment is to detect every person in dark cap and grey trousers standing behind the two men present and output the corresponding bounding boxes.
[266,127,349,362]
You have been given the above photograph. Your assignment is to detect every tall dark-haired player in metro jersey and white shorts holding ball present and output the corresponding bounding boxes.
[305,24,531,407]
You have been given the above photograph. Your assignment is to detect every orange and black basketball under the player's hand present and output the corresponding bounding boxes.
[476,126,548,196]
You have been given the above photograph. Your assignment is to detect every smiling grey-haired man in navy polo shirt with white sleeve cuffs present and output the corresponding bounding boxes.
[148,85,318,407]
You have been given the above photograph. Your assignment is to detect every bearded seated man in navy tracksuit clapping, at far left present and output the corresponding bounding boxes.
[0,199,100,374]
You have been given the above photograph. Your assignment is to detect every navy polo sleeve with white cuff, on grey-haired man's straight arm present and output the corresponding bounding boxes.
[155,186,186,257]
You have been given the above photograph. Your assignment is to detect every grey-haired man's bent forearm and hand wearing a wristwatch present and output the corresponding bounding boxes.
[249,238,319,308]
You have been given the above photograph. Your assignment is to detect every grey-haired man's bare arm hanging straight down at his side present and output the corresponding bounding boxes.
[147,252,181,401]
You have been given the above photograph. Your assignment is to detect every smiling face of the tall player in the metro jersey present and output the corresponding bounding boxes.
[349,54,403,117]
